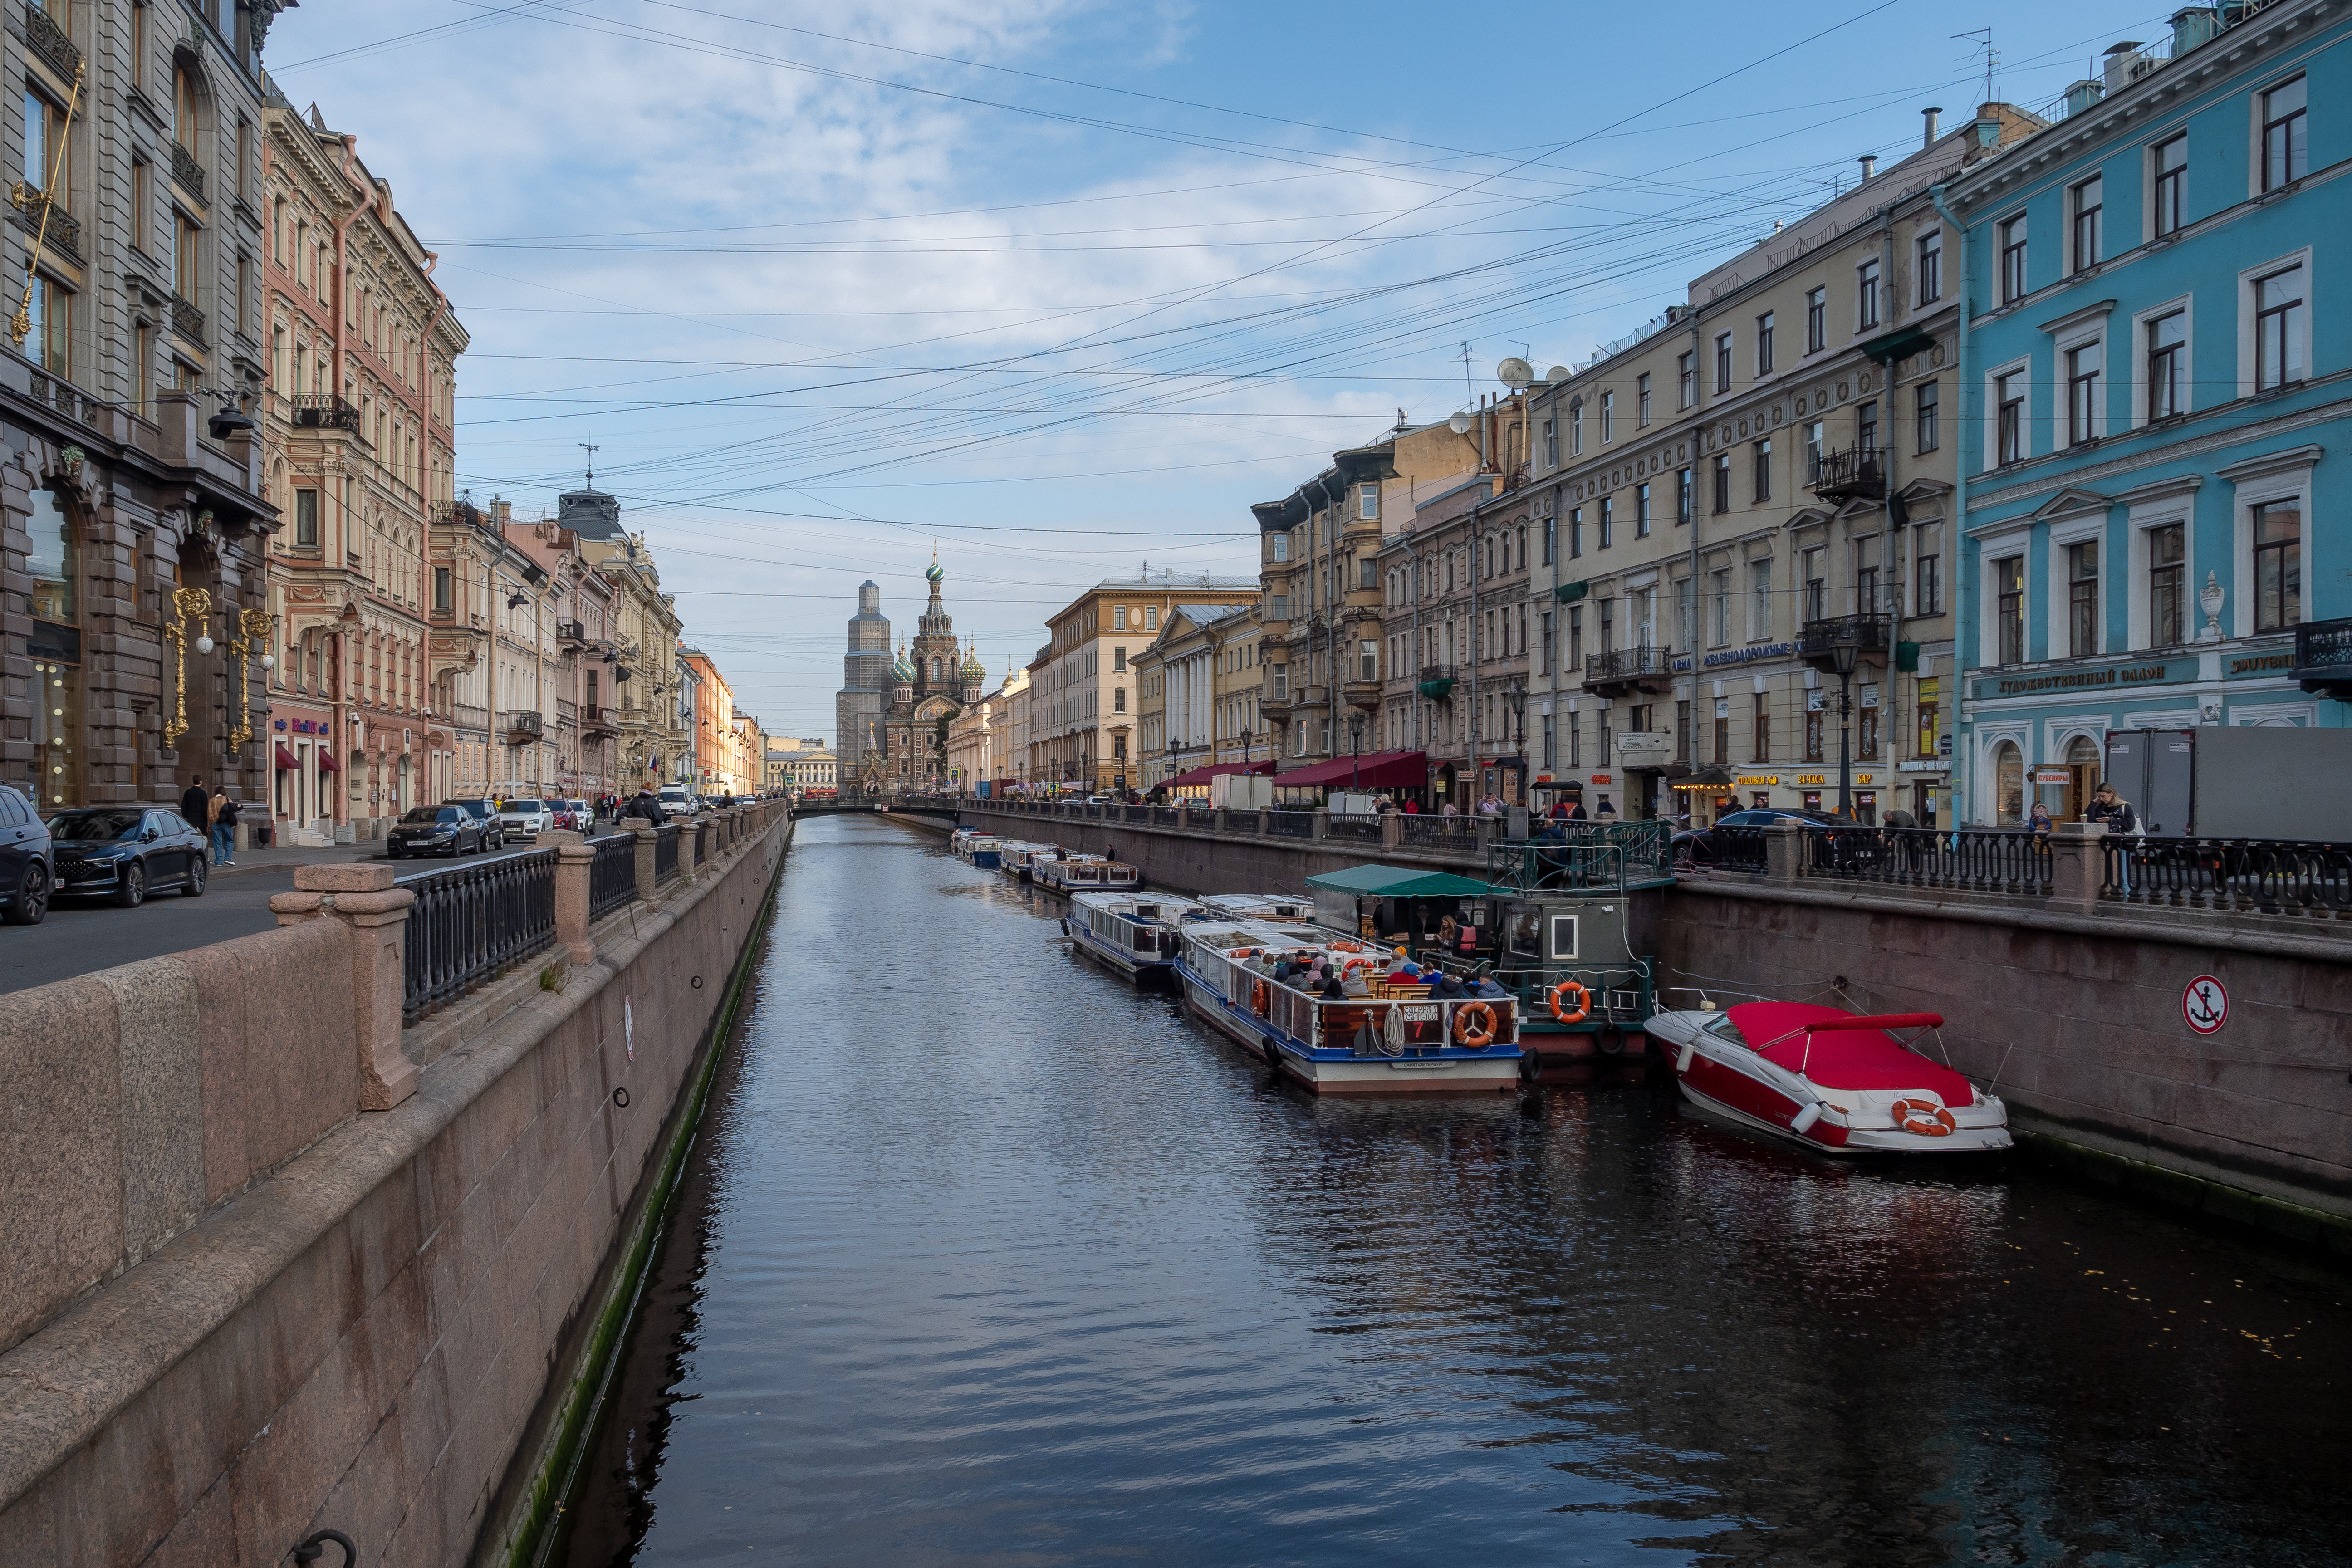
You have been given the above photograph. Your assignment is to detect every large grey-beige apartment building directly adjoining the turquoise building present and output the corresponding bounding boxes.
[1529,111,2006,823]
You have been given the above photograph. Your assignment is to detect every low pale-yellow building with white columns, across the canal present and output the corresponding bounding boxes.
[1134,604,1275,790]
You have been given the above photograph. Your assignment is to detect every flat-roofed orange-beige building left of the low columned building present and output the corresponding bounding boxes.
[1028,567,1258,790]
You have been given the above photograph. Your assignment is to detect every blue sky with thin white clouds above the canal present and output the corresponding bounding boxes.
[266,0,2176,736]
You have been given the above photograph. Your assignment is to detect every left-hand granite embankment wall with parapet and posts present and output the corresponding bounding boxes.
[0,808,790,1568]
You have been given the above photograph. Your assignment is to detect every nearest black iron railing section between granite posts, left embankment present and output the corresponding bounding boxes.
[393,848,558,1023]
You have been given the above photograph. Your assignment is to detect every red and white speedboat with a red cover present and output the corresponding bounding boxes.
[1644,1001,2009,1154]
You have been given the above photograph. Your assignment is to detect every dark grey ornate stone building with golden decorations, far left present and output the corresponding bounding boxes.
[0,0,280,827]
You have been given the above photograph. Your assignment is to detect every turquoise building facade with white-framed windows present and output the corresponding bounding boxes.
[1938,0,2352,830]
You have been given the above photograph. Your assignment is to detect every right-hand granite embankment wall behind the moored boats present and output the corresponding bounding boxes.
[936,811,2352,1251]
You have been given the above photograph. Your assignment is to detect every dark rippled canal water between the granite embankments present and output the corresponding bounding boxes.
[558,818,2352,1568]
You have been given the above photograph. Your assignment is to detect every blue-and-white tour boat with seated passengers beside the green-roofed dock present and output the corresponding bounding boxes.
[1176,919,1519,1096]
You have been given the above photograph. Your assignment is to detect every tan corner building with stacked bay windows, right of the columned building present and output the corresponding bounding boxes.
[1249,404,1486,766]
